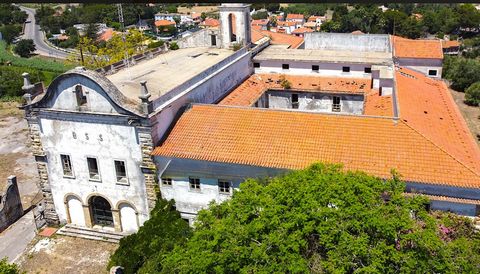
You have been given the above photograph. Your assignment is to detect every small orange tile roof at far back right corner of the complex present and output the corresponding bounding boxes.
[392,35,443,59]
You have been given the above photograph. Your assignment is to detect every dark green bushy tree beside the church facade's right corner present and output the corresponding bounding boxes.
[108,198,191,274]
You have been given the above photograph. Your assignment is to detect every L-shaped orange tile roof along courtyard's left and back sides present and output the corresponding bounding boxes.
[219,74,378,106]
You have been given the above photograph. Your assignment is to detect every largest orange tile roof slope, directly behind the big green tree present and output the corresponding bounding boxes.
[153,105,480,187]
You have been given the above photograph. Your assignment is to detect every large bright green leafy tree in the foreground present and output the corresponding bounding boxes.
[155,164,480,273]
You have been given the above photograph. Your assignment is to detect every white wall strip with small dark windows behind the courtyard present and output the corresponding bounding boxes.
[255,60,372,78]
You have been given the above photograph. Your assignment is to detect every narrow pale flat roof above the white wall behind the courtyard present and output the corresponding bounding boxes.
[253,46,393,65]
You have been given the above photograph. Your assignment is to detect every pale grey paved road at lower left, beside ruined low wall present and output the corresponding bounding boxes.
[0,211,36,262]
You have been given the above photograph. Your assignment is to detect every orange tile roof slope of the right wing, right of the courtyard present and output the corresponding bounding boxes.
[395,68,480,173]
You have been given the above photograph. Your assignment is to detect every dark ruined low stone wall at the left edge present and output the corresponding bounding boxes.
[0,176,23,232]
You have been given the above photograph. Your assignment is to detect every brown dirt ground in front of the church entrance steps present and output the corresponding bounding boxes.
[17,235,118,274]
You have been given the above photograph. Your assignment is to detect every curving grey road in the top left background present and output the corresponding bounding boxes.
[20,6,68,59]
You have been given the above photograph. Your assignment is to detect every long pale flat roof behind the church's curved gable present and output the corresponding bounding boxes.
[107,47,234,101]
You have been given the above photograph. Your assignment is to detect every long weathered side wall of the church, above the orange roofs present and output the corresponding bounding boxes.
[151,49,253,144]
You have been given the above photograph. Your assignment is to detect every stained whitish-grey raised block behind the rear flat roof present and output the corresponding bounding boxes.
[305,32,392,53]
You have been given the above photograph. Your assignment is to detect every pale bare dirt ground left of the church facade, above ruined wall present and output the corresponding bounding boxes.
[0,103,38,209]
